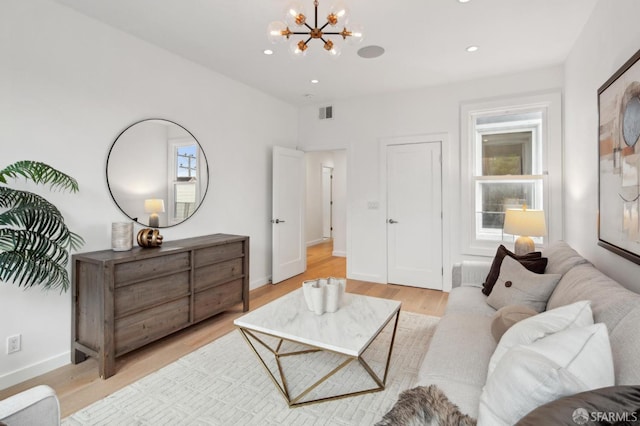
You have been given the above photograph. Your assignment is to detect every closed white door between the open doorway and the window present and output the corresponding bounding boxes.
[387,142,442,290]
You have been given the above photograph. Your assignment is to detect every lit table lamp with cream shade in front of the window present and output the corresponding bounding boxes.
[503,204,547,256]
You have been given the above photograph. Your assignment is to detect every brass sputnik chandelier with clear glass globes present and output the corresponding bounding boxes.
[268,0,362,56]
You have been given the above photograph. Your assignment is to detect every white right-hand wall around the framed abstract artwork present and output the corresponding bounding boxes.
[564,0,640,291]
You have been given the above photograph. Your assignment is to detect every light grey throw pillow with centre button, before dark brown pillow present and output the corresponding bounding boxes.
[487,257,562,312]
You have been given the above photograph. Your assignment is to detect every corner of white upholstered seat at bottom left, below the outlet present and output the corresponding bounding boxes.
[0,385,60,426]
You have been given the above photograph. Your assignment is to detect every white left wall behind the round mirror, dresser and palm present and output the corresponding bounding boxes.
[0,0,297,388]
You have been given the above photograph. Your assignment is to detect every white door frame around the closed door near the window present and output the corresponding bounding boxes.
[379,133,461,292]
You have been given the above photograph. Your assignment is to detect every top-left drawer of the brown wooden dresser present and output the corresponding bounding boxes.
[113,252,189,287]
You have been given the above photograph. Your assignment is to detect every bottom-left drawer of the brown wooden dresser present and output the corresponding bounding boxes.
[115,297,189,356]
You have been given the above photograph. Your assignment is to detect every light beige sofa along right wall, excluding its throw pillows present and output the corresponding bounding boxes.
[415,241,640,418]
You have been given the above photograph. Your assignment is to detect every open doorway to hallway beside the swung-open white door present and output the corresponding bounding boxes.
[305,150,347,261]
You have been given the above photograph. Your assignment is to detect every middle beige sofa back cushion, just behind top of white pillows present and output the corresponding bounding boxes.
[547,264,640,334]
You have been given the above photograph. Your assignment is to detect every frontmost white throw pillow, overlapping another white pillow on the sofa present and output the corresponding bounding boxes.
[478,323,614,425]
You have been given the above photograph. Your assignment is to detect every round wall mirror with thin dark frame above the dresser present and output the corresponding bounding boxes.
[107,119,209,228]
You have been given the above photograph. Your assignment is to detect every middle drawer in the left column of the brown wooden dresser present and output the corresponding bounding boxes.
[114,271,189,318]
